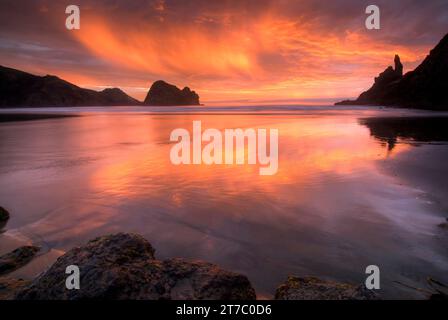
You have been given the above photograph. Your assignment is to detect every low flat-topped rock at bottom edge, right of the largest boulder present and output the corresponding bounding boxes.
[275,277,377,300]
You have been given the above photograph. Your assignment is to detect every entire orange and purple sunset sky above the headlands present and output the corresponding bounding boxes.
[0,0,448,104]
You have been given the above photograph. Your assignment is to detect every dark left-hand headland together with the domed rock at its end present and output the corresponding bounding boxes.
[0,66,200,108]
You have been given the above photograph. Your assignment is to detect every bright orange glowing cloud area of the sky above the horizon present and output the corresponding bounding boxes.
[72,10,426,101]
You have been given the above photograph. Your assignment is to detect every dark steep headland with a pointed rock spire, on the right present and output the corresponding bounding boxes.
[336,34,448,110]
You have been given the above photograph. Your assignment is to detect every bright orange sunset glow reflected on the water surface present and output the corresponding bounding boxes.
[91,115,410,196]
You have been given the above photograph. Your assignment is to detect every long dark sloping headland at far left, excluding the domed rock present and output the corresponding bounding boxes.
[0,66,140,107]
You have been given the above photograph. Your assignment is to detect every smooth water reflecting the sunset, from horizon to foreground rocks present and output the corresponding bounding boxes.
[0,106,448,298]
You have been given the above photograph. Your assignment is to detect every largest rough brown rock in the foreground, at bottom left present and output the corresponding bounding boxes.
[16,233,255,300]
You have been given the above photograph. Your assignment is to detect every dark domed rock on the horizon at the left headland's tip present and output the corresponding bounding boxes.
[144,80,199,106]
